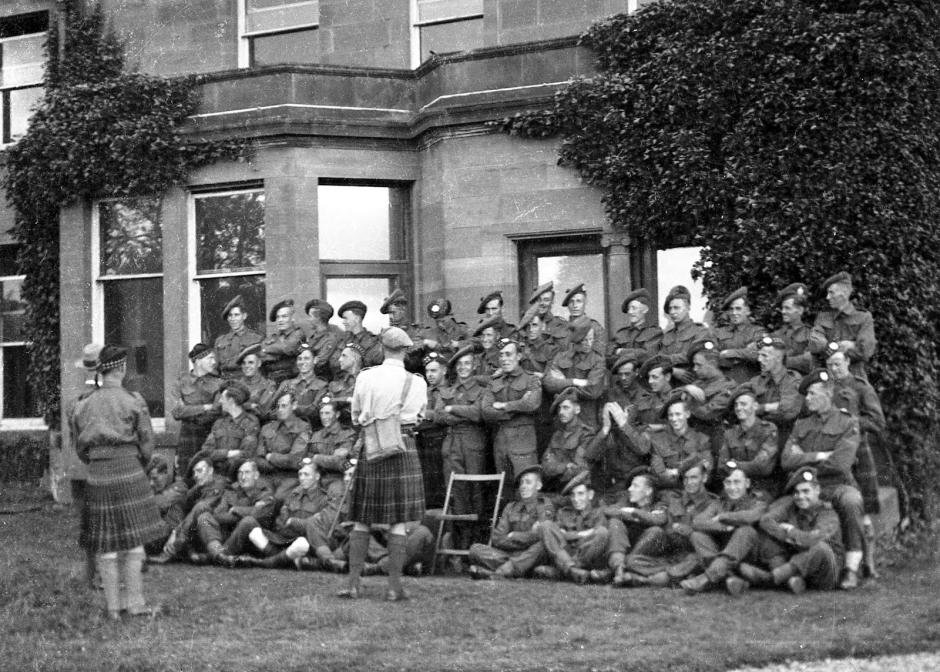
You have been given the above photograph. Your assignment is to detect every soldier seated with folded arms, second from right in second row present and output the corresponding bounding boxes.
[718,383,780,501]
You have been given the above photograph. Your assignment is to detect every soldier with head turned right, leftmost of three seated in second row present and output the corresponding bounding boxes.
[194,380,261,478]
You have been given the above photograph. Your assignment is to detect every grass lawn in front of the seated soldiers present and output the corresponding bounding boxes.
[0,490,940,671]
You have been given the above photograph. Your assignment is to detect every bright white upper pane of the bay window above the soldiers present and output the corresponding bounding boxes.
[317,185,392,260]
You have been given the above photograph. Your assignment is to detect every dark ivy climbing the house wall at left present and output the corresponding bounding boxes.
[3,2,248,426]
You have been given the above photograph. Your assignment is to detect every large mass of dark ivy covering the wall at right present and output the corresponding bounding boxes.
[502,0,940,513]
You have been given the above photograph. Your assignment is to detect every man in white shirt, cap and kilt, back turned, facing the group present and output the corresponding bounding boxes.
[337,327,428,602]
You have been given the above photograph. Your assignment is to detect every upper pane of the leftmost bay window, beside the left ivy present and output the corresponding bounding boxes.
[98,198,163,275]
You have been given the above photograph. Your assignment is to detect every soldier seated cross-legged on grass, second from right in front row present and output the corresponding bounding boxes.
[679,461,767,595]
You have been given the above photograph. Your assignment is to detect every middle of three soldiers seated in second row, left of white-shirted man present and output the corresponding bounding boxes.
[255,391,310,499]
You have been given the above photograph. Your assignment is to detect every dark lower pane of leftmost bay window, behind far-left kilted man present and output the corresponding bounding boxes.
[103,278,164,418]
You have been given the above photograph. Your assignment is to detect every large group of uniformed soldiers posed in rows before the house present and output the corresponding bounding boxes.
[121,273,885,594]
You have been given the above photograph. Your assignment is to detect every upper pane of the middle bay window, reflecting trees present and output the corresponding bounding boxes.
[196,191,264,273]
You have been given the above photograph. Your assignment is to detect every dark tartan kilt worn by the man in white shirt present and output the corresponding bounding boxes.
[349,436,424,525]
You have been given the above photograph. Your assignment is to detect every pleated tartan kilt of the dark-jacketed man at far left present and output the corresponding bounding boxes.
[85,455,166,554]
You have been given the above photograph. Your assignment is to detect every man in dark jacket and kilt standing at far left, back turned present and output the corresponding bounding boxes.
[69,346,163,620]
